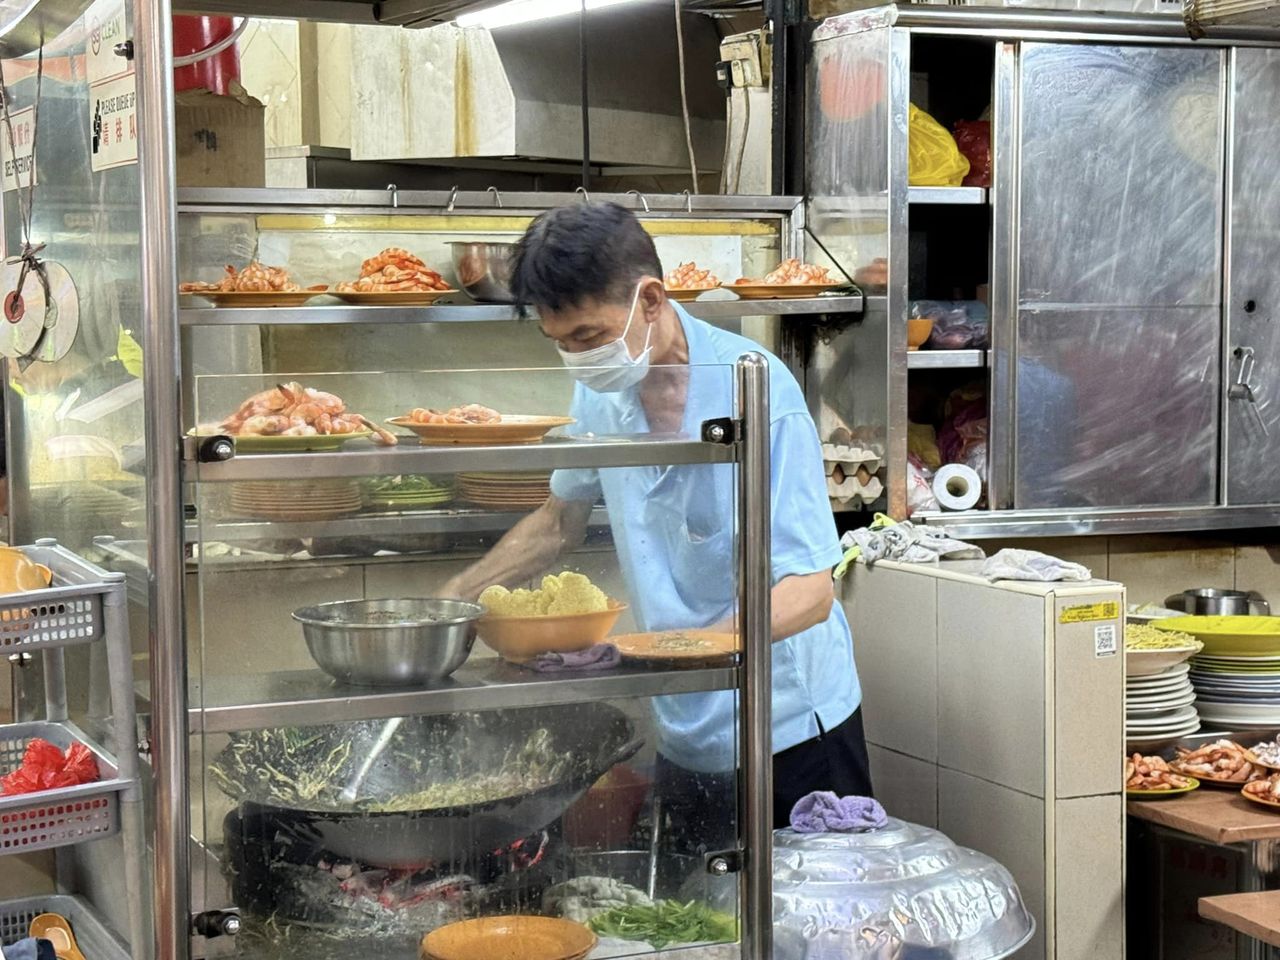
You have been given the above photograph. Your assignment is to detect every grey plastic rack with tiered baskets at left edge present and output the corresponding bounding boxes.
[0,540,150,957]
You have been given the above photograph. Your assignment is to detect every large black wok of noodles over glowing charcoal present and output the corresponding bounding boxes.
[210,704,643,867]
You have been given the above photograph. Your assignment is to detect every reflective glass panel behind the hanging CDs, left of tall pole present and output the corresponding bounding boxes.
[0,4,151,957]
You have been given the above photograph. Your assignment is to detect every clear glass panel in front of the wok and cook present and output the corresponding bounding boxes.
[191,365,739,960]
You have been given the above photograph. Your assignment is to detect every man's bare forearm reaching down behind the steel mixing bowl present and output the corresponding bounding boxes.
[440,495,591,600]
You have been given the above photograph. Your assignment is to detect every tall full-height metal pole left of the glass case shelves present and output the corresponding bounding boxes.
[133,0,191,960]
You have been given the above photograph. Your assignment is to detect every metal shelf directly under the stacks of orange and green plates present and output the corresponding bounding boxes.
[186,507,609,543]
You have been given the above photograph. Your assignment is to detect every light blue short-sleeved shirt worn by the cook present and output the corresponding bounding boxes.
[552,305,861,773]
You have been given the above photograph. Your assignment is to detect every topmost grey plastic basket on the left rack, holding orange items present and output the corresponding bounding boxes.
[0,540,124,654]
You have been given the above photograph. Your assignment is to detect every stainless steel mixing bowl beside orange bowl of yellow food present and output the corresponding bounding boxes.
[293,599,484,686]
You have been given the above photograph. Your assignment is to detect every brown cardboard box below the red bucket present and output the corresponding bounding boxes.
[174,84,266,187]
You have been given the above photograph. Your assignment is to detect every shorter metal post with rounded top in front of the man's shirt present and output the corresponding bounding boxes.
[737,353,773,960]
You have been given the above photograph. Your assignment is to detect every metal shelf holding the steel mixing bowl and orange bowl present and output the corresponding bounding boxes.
[188,660,737,733]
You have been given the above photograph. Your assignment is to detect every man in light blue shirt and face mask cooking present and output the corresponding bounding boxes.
[445,204,872,846]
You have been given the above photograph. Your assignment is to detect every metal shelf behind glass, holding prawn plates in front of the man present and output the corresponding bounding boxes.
[186,434,735,483]
